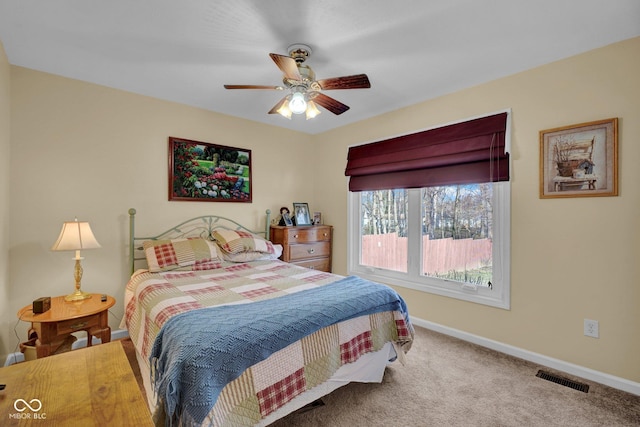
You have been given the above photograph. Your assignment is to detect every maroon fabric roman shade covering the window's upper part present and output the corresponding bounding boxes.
[345,113,509,191]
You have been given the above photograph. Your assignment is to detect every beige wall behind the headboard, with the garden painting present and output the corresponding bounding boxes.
[5,66,314,360]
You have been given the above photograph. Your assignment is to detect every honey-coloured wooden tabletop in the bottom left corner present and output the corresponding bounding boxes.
[0,341,153,426]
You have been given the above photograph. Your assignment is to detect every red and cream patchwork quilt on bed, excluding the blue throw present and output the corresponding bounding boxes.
[125,260,413,426]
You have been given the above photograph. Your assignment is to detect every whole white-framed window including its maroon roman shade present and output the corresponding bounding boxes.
[345,111,511,309]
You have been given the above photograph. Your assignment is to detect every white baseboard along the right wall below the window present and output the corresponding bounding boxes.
[411,316,640,396]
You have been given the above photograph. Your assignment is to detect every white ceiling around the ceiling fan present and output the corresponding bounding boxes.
[0,0,640,134]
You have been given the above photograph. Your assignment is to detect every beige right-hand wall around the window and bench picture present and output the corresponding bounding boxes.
[314,38,640,382]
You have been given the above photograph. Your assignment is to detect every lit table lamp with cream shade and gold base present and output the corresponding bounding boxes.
[51,218,100,301]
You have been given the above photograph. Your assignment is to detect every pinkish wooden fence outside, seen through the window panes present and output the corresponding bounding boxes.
[362,233,492,274]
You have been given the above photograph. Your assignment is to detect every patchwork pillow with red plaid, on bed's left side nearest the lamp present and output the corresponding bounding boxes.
[142,238,220,273]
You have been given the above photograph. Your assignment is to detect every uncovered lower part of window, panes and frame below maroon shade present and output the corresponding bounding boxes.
[349,182,510,309]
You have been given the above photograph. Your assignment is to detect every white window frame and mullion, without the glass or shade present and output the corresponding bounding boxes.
[347,110,511,310]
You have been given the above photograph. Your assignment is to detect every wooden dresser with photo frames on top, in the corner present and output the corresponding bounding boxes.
[270,225,333,272]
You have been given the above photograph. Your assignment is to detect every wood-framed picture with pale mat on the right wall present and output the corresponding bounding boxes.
[540,118,618,199]
